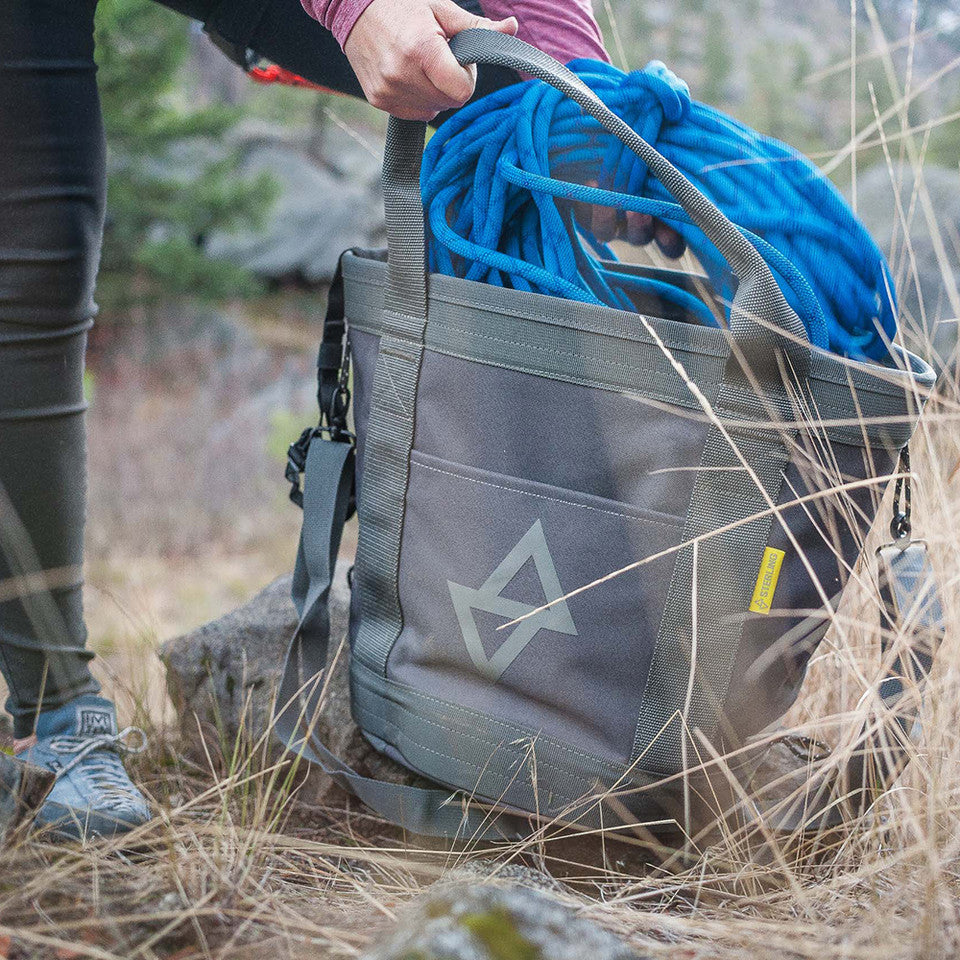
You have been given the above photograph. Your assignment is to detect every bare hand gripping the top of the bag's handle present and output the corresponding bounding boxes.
[343,0,517,120]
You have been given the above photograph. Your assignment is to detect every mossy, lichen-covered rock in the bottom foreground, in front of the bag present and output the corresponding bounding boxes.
[365,883,637,960]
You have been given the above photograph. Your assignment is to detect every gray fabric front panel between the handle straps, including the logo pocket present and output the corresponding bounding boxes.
[387,350,703,763]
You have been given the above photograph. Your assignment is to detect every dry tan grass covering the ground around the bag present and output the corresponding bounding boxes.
[0,3,960,960]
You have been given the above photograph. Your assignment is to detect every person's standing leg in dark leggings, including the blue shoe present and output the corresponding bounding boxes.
[0,0,150,837]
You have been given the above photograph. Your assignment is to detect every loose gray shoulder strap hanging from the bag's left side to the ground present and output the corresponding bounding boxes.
[273,438,529,840]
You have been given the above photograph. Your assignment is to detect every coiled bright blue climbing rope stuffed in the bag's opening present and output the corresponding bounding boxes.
[421,60,896,360]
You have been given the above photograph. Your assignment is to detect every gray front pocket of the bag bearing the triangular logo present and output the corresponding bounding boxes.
[387,451,683,761]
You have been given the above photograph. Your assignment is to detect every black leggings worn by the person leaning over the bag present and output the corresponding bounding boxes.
[0,0,514,736]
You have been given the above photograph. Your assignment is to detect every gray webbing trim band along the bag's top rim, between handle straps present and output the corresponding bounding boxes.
[343,255,934,450]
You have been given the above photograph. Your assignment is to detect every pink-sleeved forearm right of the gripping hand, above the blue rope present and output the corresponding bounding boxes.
[480,0,610,63]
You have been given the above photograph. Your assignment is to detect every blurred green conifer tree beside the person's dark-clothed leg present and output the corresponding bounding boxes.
[96,0,275,320]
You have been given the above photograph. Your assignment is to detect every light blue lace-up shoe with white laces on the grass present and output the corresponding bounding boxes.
[18,696,150,840]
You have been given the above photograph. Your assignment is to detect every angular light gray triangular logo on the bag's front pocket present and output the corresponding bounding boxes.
[447,520,577,681]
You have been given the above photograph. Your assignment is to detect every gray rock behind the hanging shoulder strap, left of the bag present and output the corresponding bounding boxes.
[160,557,417,804]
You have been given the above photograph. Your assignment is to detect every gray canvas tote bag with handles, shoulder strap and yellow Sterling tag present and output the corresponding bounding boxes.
[276,31,933,838]
